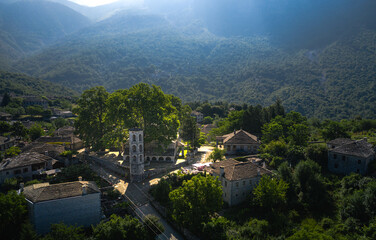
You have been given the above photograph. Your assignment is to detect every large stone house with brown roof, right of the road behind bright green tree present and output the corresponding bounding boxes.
[206,159,272,206]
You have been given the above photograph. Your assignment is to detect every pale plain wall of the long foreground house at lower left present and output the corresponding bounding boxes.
[28,193,101,234]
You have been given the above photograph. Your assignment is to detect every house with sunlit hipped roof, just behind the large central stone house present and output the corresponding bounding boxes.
[216,130,260,155]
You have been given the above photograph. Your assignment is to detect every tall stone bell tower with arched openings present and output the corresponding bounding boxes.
[129,128,144,182]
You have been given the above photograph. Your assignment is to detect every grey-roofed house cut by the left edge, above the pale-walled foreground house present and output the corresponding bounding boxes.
[0,152,57,183]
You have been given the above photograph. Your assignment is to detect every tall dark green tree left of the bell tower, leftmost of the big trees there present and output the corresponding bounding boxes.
[73,86,109,150]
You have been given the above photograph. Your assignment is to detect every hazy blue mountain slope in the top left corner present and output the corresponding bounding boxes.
[0,0,90,62]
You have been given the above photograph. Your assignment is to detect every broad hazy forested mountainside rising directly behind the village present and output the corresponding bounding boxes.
[0,0,376,119]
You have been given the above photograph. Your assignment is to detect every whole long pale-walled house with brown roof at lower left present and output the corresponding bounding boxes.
[23,181,101,234]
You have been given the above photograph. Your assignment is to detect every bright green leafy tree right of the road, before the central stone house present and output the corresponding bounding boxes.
[169,175,223,231]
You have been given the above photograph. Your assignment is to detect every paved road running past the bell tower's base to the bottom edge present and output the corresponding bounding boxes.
[90,164,184,240]
